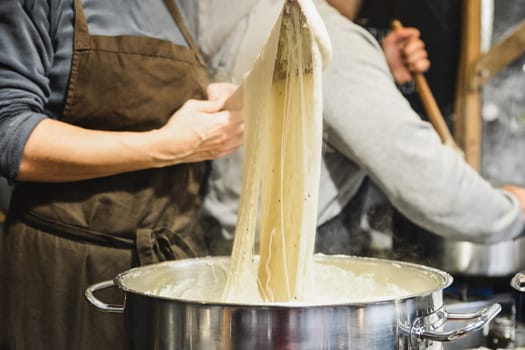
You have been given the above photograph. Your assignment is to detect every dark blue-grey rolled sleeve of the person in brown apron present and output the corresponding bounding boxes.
[0,0,53,181]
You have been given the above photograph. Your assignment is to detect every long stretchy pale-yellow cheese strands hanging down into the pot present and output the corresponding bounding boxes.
[223,0,330,302]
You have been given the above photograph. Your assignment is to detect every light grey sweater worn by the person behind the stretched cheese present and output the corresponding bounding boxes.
[201,0,524,242]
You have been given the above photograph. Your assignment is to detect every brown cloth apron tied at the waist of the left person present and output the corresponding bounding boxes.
[0,0,211,350]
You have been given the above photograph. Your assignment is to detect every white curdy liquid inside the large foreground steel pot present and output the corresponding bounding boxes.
[137,261,434,305]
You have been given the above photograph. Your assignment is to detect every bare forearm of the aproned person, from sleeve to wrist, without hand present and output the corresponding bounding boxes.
[17,119,177,182]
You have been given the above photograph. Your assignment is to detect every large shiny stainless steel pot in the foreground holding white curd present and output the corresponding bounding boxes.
[85,256,501,350]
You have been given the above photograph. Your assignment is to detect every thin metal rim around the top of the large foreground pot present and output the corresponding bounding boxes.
[113,254,453,309]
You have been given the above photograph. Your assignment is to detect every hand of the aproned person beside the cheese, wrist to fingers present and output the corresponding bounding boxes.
[158,83,244,163]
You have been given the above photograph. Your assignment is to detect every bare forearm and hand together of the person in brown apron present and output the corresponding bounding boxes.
[16,93,243,182]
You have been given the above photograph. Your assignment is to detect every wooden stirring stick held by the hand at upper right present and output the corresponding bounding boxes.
[392,20,463,155]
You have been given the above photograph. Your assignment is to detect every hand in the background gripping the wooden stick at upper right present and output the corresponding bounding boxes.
[382,27,430,84]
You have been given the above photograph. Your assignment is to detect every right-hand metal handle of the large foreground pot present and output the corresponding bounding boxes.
[411,303,501,342]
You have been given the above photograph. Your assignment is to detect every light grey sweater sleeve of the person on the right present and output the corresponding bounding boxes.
[320,2,524,242]
